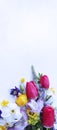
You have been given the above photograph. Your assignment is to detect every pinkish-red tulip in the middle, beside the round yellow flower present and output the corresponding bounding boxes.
[26,81,38,99]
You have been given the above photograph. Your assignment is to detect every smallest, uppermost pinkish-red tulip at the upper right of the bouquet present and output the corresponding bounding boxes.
[40,75,50,89]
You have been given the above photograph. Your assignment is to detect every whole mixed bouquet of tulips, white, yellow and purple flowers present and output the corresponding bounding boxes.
[0,66,57,130]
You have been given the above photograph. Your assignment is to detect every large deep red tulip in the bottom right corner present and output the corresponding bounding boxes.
[42,106,54,128]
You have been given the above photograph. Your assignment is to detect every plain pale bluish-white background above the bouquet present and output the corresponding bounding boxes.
[0,0,57,105]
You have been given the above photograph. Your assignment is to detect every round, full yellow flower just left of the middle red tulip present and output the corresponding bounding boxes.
[15,94,28,106]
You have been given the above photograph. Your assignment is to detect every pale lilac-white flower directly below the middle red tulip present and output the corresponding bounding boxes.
[27,99,43,113]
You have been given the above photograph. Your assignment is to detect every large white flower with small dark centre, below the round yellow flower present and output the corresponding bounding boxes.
[6,103,22,126]
